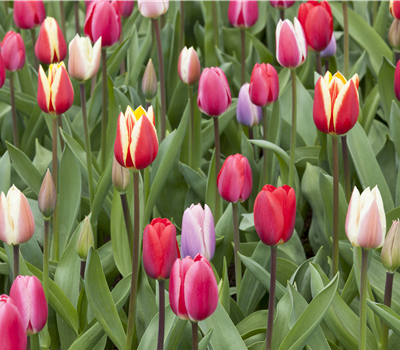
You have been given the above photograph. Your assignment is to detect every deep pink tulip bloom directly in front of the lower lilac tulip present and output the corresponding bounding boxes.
[169,254,218,322]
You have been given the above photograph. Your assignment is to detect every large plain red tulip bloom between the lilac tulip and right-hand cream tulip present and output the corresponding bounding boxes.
[254,185,296,246]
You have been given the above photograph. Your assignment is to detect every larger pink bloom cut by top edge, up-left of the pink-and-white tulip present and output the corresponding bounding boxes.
[228,0,258,28]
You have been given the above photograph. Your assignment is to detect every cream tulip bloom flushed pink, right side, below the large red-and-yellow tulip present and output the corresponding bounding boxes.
[345,186,386,249]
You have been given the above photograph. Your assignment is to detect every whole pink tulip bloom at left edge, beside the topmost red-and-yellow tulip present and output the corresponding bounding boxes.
[1,30,25,72]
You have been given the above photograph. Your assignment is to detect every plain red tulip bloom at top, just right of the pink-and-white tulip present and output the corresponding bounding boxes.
[299,0,333,52]
